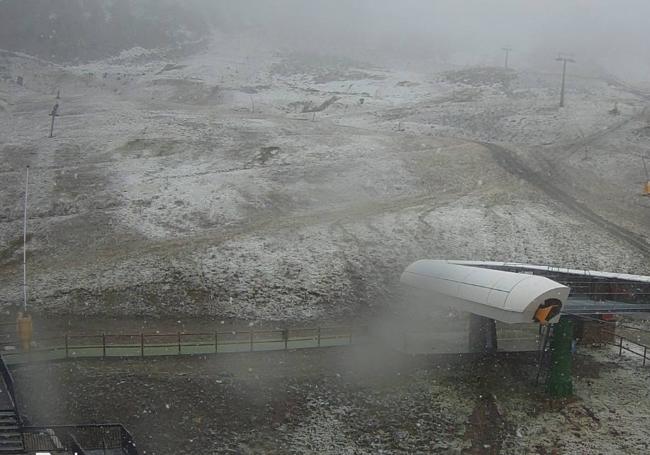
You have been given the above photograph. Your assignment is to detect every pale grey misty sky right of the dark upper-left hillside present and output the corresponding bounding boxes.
[219,0,650,80]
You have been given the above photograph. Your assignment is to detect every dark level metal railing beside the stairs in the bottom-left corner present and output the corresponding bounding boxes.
[23,424,138,455]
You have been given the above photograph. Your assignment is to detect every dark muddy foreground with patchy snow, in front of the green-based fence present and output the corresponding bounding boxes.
[8,346,650,455]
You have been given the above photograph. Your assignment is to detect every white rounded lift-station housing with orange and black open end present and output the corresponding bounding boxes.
[400,260,569,324]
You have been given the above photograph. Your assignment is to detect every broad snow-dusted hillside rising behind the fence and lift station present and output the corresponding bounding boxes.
[0,36,650,320]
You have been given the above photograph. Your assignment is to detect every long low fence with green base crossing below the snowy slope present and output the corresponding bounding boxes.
[0,327,366,364]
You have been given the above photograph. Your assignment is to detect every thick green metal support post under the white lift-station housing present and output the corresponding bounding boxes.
[546,317,573,398]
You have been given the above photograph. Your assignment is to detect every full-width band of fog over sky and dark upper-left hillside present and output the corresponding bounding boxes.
[0,0,650,81]
